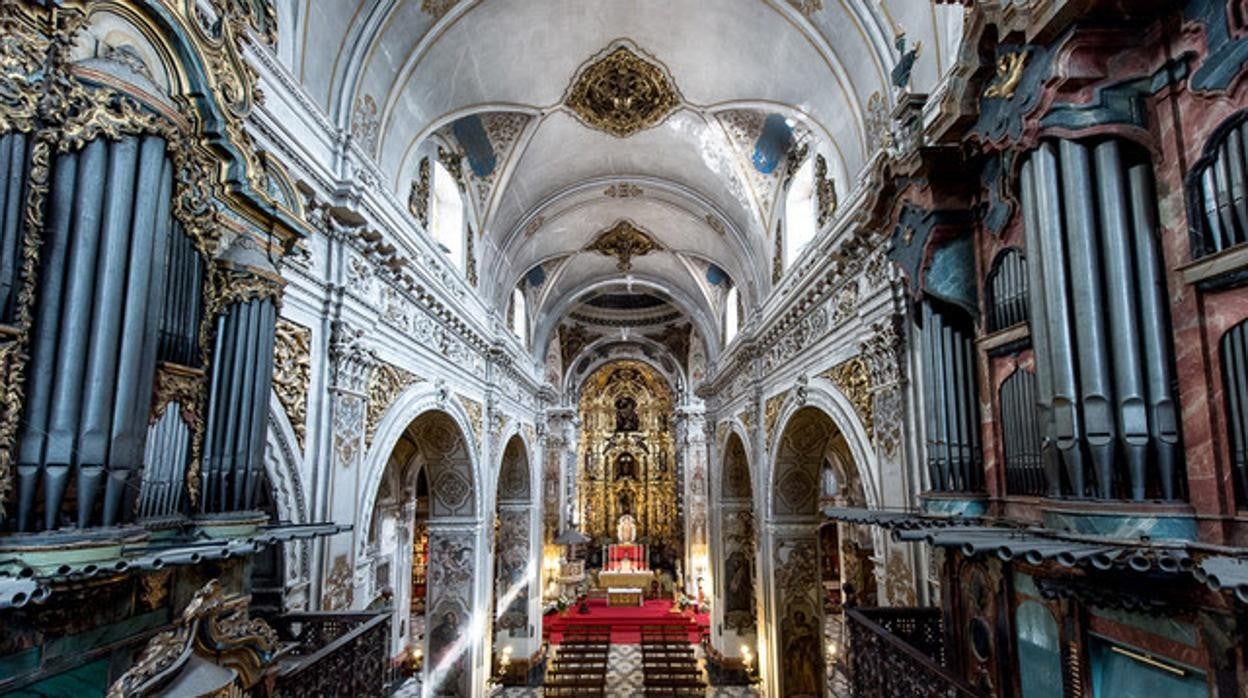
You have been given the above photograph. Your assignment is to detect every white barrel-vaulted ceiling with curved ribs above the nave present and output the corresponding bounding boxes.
[277,0,962,367]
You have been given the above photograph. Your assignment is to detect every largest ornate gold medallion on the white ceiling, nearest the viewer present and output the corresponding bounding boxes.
[564,45,680,137]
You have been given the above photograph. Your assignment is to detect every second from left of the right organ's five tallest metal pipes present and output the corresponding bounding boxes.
[1033,142,1086,497]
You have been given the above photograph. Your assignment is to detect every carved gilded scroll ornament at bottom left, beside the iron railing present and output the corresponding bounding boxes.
[107,579,277,698]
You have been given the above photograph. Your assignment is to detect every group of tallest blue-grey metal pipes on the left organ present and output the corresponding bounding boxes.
[17,136,173,531]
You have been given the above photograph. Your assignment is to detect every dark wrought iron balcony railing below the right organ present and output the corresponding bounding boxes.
[845,608,978,698]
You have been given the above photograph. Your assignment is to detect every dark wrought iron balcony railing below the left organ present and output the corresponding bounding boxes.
[270,611,394,698]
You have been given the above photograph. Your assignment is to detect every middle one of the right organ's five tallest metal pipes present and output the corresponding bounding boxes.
[1060,141,1119,498]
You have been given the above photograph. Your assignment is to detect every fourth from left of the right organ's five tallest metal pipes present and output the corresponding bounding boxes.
[1090,140,1148,499]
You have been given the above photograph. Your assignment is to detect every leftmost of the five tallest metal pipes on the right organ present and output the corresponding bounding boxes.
[1018,159,1062,497]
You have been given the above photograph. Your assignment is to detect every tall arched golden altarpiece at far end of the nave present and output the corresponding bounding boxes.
[577,361,681,549]
